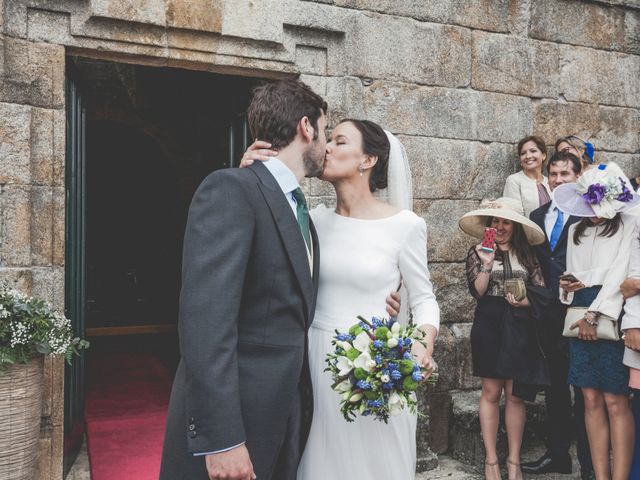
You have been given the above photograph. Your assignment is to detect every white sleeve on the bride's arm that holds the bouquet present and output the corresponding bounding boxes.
[399,218,440,330]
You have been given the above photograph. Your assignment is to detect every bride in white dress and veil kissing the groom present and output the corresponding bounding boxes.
[242,120,440,480]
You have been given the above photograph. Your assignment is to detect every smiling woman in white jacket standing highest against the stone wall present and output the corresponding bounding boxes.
[503,136,551,217]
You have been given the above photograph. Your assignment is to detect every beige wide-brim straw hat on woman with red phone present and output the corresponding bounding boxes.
[458,197,545,245]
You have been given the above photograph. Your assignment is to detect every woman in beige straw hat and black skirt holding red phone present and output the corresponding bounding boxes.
[459,197,546,480]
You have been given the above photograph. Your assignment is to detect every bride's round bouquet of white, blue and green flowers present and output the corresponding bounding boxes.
[325,316,437,423]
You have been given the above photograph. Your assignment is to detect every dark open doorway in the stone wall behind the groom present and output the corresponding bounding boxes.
[65,57,259,476]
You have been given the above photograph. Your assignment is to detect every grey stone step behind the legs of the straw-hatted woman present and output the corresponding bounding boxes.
[447,390,545,465]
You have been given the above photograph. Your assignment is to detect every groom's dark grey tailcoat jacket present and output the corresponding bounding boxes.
[160,162,320,480]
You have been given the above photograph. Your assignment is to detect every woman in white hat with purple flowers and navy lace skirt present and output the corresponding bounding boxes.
[554,163,640,479]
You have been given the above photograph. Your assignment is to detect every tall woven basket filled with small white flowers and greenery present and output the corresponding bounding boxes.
[0,285,89,480]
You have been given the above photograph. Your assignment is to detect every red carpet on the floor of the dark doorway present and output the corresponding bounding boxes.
[85,353,172,480]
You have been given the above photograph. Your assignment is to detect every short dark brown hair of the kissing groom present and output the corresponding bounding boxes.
[247,79,327,150]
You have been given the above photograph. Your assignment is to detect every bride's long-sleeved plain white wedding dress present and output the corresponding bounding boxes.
[298,205,440,480]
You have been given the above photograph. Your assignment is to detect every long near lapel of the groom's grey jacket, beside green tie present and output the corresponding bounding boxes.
[249,162,317,323]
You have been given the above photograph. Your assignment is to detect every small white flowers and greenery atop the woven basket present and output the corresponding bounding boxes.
[0,285,89,372]
